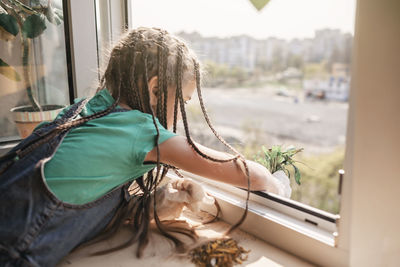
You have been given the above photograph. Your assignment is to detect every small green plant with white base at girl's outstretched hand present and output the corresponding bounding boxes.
[256,146,303,198]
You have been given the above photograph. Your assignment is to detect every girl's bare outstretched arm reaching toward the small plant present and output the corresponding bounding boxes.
[145,136,281,194]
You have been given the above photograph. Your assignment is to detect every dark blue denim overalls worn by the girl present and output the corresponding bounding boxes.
[0,101,131,266]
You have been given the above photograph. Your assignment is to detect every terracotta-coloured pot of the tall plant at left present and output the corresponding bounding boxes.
[10,105,65,138]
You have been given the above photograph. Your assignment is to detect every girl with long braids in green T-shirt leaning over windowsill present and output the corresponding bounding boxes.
[0,28,290,266]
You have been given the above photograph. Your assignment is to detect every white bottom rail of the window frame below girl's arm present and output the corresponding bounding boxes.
[168,172,348,266]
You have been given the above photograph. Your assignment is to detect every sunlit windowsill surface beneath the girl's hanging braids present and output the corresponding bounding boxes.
[57,204,313,267]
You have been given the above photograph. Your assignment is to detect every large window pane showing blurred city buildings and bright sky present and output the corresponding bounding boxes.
[131,0,355,213]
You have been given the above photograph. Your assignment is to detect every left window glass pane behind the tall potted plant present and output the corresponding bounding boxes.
[0,0,69,141]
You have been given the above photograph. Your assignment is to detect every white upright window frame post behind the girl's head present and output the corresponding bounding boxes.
[63,0,128,97]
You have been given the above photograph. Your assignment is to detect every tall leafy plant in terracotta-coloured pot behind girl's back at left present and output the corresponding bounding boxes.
[0,0,64,138]
